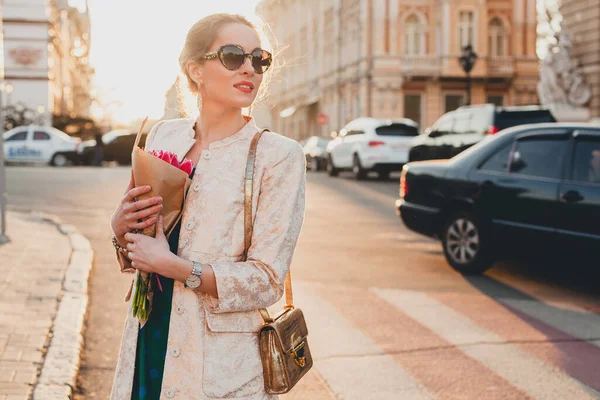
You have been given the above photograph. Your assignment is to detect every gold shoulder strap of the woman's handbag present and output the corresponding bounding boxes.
[243,129,294,322]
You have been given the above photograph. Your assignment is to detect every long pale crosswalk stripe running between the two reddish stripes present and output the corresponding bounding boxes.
[372,289,596,400]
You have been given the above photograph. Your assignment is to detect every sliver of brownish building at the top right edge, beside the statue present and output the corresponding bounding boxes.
[560,0,600,118]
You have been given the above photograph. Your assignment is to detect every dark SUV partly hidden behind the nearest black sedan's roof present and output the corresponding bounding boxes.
[408,104,556,162]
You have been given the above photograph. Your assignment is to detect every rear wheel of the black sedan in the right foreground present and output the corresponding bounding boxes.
[441,212,494,275]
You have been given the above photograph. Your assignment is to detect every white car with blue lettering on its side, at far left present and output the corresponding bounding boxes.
[3,125,81,167]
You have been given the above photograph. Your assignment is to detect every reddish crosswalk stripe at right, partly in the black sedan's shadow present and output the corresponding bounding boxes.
[430,292,600,391]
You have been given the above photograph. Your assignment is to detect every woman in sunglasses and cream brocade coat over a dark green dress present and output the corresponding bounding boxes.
[111,14,306,400]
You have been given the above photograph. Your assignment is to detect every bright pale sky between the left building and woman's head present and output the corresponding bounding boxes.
[78,0,259,123]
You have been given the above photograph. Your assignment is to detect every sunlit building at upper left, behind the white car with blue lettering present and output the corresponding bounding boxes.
[3,0,94,124]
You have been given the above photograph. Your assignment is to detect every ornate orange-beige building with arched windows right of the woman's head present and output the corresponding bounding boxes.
[258,0,539,139]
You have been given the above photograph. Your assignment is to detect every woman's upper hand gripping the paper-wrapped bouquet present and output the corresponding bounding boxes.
[111,174,163,244]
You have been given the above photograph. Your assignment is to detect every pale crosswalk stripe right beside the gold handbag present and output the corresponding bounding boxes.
[294,282,435,400]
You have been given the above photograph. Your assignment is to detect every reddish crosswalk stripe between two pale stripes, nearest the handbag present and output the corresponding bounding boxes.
[317,287,527,400]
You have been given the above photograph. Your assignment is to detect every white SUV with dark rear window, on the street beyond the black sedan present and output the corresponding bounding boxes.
[327,118,419,179]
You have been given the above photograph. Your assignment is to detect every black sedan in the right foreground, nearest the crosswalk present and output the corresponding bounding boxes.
[396,123,600,273]
